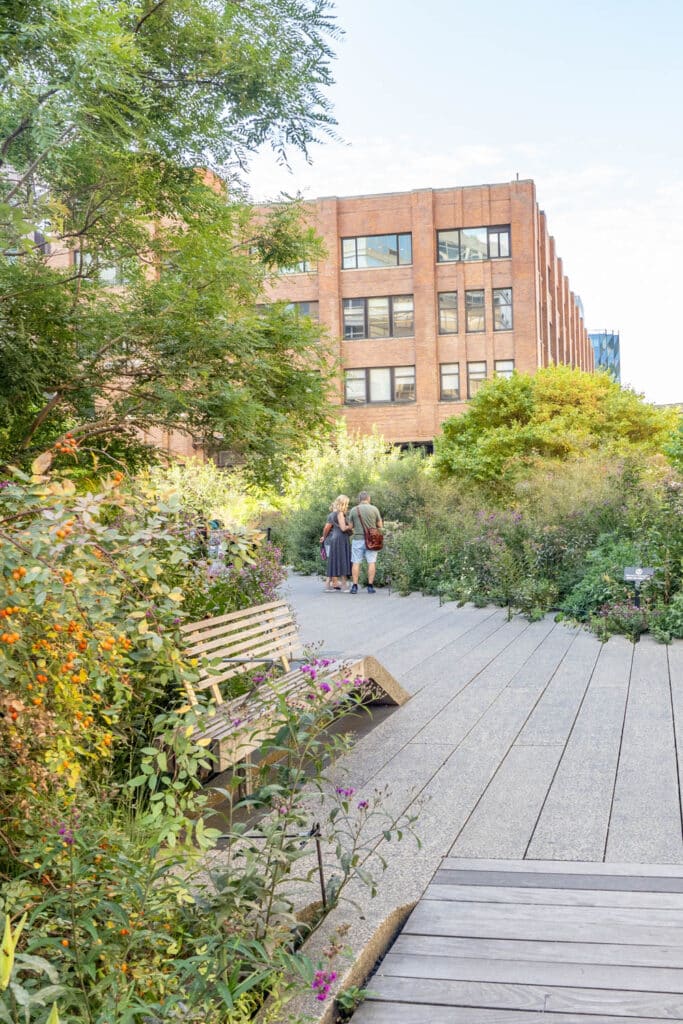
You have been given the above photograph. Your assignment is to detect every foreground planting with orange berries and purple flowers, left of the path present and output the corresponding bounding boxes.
[0,458,412,1024]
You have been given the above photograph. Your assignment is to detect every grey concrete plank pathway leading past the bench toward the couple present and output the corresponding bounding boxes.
[278,577,683,1024]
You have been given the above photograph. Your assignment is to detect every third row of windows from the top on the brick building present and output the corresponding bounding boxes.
[344,359,515,406]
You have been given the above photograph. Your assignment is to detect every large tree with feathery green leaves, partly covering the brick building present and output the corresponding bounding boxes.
[0,0,336,476]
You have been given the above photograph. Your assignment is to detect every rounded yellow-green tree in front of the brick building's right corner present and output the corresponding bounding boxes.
[434,366,678,489]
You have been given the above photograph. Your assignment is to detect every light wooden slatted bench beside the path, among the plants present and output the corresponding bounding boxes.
[180,601,410,771]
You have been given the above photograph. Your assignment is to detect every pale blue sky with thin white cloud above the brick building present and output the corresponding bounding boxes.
[249,0,683,402]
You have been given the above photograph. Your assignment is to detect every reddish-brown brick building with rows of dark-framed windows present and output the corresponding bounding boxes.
[270,181,593,442]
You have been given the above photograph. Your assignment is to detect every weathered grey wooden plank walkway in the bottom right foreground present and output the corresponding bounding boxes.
[353,857,683,1024]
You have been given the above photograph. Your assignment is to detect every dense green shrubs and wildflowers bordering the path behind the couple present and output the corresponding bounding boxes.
[281,425,683,638]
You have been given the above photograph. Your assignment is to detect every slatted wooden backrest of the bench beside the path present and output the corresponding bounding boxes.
[180,601,299,703]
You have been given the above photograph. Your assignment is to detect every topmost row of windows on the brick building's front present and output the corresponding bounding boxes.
[281,224,511,273]
